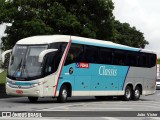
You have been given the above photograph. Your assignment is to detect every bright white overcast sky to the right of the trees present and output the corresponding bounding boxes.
[112,0,160,57]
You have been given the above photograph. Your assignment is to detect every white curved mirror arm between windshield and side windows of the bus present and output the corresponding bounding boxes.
[38,49,58,63]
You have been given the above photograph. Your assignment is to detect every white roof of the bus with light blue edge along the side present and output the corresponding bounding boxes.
[16,35,154,53]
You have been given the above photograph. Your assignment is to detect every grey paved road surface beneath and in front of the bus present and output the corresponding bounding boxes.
[0,90,160,120]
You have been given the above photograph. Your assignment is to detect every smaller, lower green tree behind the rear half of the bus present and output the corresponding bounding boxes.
[113,21,149,48]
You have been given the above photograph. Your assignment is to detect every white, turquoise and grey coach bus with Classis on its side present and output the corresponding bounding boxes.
[2,35,157,103]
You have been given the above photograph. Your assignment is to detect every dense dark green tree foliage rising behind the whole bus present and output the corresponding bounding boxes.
[0,0,148,49]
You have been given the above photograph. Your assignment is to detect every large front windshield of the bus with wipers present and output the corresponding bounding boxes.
[8,45,48,79]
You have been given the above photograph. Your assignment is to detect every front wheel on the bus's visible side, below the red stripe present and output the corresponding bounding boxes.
[57,85,68,103]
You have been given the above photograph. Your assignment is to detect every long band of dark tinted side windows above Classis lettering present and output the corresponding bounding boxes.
[65,44,156,67]
